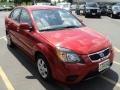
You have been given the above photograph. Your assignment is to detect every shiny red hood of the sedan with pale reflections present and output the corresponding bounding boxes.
[41,27,110,54]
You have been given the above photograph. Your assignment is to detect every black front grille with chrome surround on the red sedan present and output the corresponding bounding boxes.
[89,48,110,61]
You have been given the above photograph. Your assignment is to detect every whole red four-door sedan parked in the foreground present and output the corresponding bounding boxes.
[5,6,114,84]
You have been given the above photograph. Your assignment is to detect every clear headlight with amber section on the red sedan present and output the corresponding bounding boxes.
[57,47,81,62]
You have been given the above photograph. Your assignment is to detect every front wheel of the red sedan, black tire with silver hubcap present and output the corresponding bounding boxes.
[36,54,52,81]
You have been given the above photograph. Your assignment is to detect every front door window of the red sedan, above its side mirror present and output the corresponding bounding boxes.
[20,9,31,25]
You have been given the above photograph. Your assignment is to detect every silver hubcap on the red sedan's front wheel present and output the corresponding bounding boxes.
[37,59,48,78]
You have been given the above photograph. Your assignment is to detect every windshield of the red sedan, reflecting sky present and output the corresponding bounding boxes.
[32,9,82,31]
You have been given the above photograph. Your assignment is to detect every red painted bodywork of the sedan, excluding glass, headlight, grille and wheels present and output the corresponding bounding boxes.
[5,6,114,83]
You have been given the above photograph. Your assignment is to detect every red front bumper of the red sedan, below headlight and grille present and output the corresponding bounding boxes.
[53,47,114,84]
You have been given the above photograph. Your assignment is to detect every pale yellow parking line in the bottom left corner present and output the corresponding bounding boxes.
[0,67,15,90]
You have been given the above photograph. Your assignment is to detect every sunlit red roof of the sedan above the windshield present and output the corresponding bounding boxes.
[20,5,59,11]
